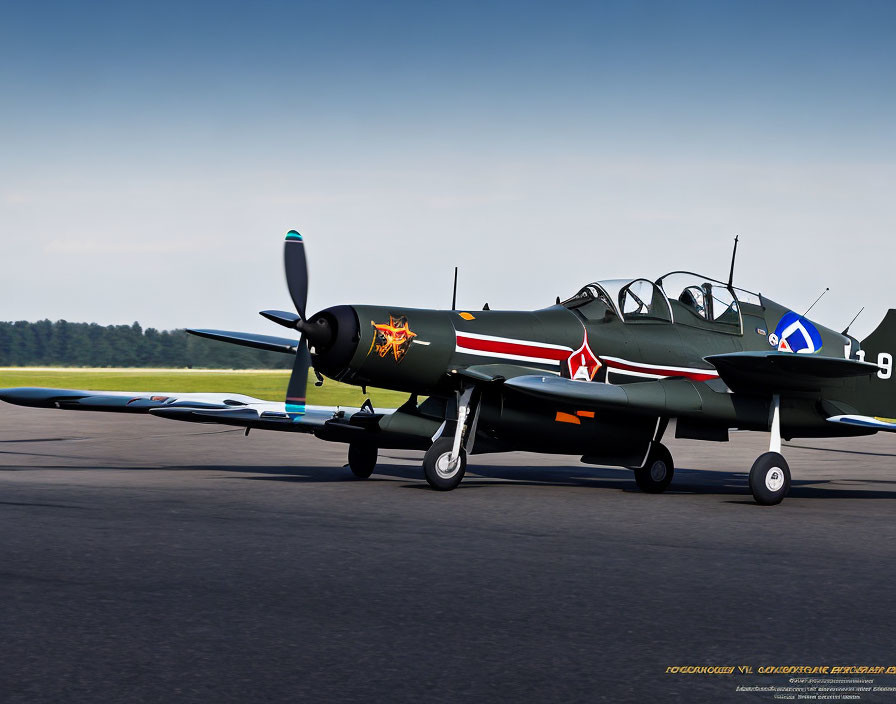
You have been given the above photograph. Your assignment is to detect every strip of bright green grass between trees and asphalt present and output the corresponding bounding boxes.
[0,367,408,408]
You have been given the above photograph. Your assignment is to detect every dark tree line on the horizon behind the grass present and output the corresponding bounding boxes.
[0,320,292,369]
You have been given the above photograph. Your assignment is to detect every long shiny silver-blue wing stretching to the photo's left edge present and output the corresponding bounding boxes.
[0,387,374,433]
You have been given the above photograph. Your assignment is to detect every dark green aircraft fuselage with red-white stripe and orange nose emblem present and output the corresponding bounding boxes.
[315,276,857,465]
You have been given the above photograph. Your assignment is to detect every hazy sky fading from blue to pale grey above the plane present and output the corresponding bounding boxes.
[0,2,896,332]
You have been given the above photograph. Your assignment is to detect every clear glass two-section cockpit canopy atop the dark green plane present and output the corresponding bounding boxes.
[562,271,761,333]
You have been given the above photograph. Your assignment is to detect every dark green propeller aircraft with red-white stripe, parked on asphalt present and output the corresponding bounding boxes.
[0,230,896,505]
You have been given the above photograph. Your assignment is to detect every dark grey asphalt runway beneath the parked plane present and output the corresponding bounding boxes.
[0,404,896,704]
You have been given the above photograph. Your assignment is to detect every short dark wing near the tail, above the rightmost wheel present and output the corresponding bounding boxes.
[706,351,879,395]
